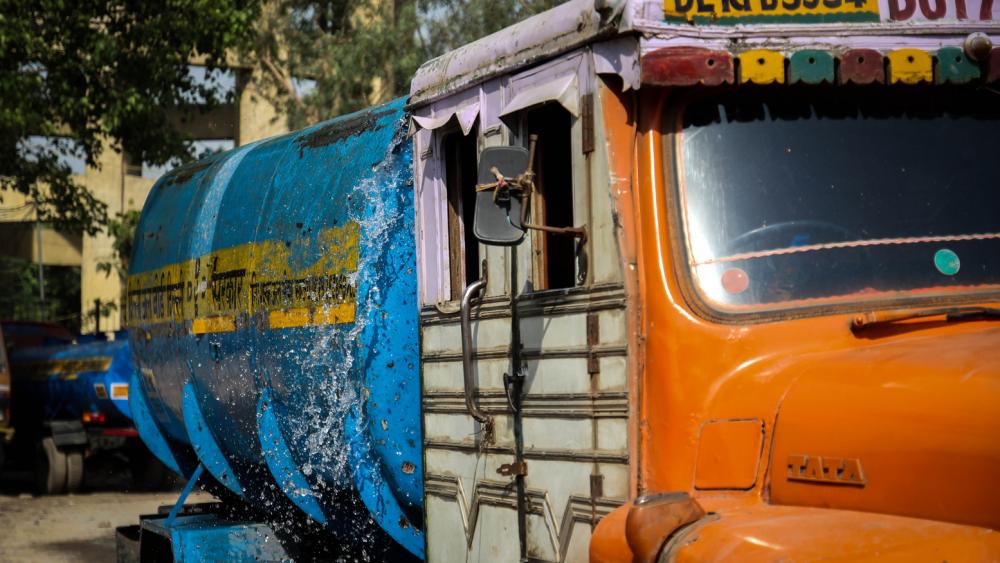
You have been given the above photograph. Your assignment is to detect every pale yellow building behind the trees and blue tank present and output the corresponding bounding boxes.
[0,65,288,333]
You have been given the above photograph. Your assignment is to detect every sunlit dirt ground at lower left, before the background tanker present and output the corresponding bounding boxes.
[0,456,212,563]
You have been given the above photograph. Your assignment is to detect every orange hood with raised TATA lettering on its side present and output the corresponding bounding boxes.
[768,323,1000,529]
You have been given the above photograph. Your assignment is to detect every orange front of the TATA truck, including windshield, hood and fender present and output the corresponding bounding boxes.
[591,57,1000,561]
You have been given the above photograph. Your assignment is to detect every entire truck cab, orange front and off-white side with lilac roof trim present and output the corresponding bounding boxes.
[410,0,1000,562]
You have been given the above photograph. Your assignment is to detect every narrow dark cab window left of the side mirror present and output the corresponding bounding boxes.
[441,128,481,300]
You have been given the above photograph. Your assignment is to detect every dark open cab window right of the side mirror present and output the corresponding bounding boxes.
[522,103,577,290]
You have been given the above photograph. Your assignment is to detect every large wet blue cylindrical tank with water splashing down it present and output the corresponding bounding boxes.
[126,100,424,557]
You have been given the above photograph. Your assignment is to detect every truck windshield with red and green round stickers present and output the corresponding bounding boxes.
[671,86,1000,312]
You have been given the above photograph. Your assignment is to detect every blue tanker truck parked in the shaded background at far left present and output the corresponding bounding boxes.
[0,332,167,494]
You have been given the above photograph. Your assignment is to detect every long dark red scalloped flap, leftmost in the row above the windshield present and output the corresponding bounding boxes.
[642,47,734,86]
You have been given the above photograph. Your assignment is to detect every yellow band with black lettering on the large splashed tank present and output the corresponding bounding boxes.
[125,222,360,334]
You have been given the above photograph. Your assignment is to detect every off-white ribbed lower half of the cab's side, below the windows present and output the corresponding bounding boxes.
[421,294,629,561]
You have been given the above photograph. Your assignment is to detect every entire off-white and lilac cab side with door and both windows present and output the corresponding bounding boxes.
[415,51,629,561]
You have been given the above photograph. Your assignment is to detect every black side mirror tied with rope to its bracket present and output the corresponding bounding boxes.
[472,147,531,246]
